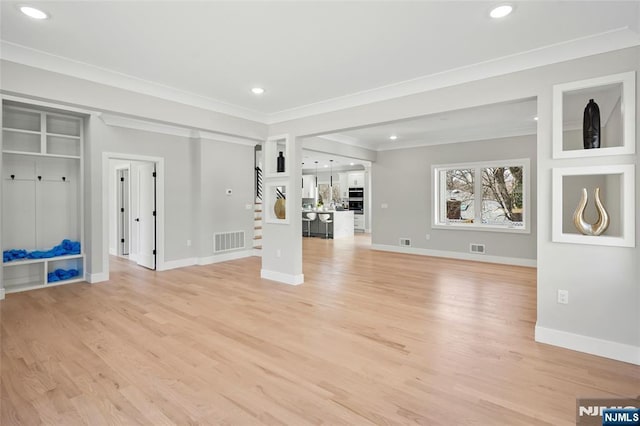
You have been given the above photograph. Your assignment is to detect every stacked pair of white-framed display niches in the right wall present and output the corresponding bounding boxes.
[552,71,636,247]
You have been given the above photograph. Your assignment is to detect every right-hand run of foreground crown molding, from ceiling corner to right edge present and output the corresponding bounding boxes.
[267,27,640,124]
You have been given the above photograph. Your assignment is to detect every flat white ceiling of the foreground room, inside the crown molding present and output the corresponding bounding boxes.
[0,0,640,123]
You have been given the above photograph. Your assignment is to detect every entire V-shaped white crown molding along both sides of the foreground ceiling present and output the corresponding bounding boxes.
[0,27,640,125]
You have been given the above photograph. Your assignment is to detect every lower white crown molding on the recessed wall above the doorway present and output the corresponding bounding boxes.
[97,113,262,146]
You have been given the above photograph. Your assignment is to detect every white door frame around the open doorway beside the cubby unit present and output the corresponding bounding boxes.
[102,152,165,274]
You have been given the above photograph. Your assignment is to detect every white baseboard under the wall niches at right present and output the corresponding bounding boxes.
[536,325,640,365]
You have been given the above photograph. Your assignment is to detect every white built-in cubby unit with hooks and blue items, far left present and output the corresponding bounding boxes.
[2,103,85,293]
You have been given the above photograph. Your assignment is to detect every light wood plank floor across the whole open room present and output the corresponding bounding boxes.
[0,236,640,426]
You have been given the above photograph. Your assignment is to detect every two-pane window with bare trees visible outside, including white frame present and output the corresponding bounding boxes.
[433,159,529,232]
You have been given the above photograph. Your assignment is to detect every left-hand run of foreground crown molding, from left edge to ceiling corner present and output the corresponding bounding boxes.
[0,40,266,123]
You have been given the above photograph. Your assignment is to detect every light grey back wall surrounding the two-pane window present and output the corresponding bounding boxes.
[371,135,537,264]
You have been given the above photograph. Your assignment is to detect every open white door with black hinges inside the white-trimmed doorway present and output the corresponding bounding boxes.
[136,163,156,269]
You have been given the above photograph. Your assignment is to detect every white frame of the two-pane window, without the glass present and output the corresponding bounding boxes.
[431,158,531,234]
